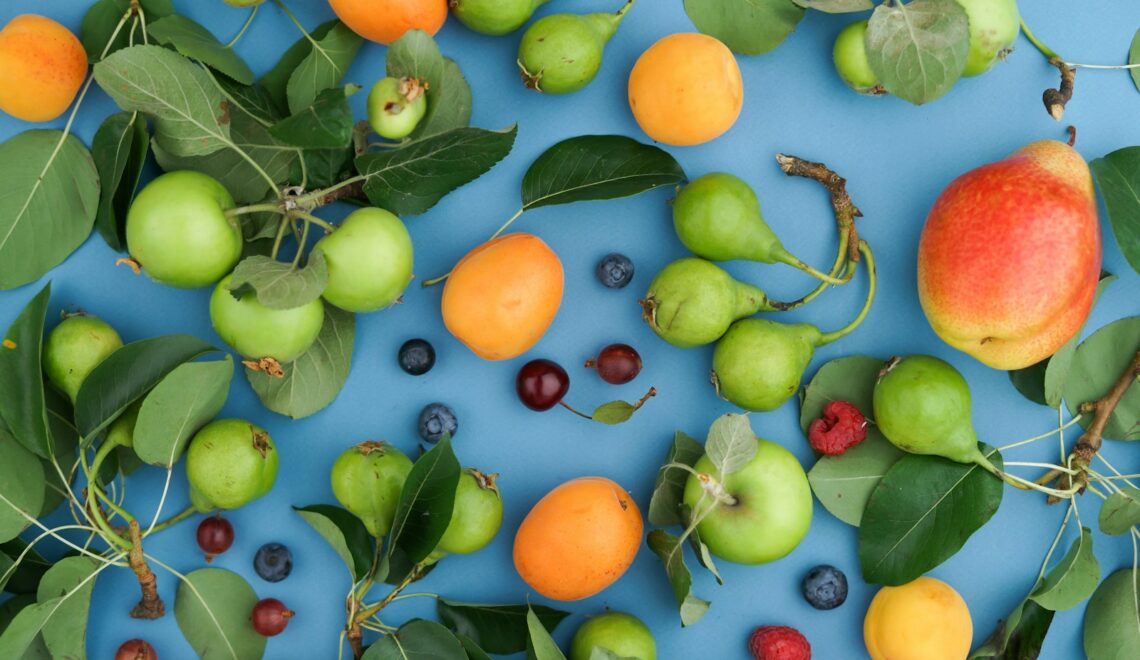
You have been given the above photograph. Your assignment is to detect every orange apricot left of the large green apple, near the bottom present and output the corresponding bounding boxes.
[514,476,643,601]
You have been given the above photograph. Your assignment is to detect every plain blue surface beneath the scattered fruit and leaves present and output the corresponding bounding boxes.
[0,0,1140,660]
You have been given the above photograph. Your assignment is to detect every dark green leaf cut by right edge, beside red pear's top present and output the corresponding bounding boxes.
[1089,148,1140,272]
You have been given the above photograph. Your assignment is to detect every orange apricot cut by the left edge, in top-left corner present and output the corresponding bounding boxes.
[0,14,87,122]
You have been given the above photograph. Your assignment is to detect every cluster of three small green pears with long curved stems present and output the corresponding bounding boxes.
[641,172,876,410]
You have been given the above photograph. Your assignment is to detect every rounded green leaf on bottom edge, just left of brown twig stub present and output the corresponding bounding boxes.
[36,556,98,659]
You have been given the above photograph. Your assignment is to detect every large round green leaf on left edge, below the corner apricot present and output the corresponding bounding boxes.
[0,130,99,290]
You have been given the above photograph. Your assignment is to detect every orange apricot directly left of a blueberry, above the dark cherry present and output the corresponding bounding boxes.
[441,234,562,360]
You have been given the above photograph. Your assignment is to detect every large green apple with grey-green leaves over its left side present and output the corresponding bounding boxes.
[684,439,812,564]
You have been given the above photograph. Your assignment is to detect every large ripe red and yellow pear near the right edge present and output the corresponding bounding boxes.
[918,140,1100,369]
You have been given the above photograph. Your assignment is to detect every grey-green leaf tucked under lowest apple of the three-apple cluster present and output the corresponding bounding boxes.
[245,304,356,419]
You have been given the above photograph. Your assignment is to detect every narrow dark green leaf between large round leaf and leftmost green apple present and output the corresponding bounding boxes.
[91,112,150,252]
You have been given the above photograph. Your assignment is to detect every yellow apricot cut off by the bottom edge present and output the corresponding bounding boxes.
[863,576,974,660]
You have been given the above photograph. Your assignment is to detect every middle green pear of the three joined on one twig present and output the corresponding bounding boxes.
[641,256,774,349]
